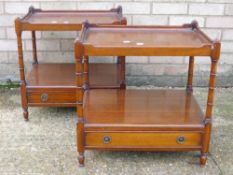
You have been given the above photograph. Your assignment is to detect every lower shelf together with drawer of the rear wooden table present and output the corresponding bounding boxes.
[26,63,120,107]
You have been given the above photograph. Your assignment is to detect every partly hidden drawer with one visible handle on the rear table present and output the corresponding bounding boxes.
[28,91,76,105]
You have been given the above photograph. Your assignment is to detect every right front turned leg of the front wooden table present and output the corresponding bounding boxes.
[200,42,220,165]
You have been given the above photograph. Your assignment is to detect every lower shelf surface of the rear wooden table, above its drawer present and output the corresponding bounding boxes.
[27,63,120,88]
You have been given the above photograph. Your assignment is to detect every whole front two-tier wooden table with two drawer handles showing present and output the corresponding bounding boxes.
[75,22,220,165]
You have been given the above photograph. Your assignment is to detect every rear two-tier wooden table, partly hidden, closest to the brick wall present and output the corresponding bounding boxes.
[15,7,127,120]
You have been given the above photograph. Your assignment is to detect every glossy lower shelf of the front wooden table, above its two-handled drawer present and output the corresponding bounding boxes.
[84,89,204,131]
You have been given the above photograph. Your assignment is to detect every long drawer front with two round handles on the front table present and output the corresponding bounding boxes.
[85,132,201,148]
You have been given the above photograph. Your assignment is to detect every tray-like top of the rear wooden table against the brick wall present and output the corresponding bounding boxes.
[17,6,125,30]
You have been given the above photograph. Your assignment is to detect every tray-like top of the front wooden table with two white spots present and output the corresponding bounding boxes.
[78,23,218,56]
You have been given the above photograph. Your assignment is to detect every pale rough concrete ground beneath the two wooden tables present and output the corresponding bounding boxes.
[0,87,233,175]
